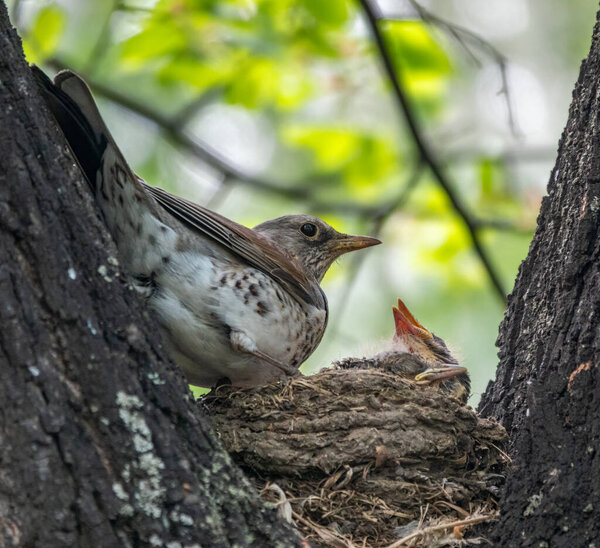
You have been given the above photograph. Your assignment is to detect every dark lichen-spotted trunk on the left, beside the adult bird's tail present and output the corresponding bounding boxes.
[0,2,300,548]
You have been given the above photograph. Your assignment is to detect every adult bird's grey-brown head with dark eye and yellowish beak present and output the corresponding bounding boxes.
[253,215,381,282]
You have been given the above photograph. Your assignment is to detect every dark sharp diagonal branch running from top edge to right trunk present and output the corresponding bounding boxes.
[359,0,506,303]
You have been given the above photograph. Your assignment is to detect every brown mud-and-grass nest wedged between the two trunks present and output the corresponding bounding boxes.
[203,368,508,547]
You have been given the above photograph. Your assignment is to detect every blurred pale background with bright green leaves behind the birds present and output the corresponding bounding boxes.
[8,0,598,404]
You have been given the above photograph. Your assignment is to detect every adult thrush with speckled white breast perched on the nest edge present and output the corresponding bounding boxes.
[33,67,381,387]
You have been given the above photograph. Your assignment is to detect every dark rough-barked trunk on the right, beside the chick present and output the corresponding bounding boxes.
[480,6,600,547]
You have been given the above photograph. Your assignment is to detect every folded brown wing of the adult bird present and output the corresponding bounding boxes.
[140,183,325,308]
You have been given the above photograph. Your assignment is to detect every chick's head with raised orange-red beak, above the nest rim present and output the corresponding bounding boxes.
[393,299,458,365]
